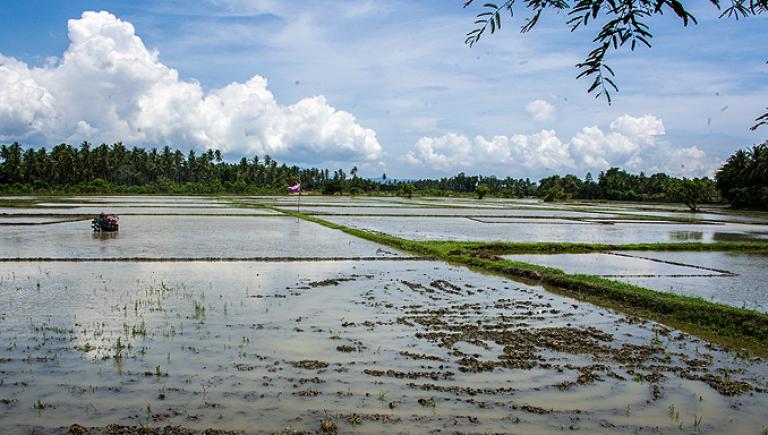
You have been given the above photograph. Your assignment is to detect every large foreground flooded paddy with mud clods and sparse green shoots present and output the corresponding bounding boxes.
[0,261,768,433]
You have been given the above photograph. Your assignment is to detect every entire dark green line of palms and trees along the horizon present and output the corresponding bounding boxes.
[0,142,768,210]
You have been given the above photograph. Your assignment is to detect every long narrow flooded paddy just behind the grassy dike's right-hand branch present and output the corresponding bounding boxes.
[325,216,768,244]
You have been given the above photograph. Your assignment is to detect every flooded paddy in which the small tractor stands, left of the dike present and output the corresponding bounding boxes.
[0,216,396,258]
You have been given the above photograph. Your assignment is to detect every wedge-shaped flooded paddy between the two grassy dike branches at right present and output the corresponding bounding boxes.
[504,251,768,312]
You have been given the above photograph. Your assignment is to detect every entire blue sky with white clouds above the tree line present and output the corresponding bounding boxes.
[0,0,768,178]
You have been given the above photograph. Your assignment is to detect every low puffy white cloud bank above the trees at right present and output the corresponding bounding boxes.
[402,115,722,177]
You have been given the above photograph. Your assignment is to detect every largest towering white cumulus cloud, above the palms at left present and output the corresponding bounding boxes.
[0,11,382,163]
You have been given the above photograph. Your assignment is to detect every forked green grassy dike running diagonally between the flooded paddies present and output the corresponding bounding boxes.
[278,209,768,355]
